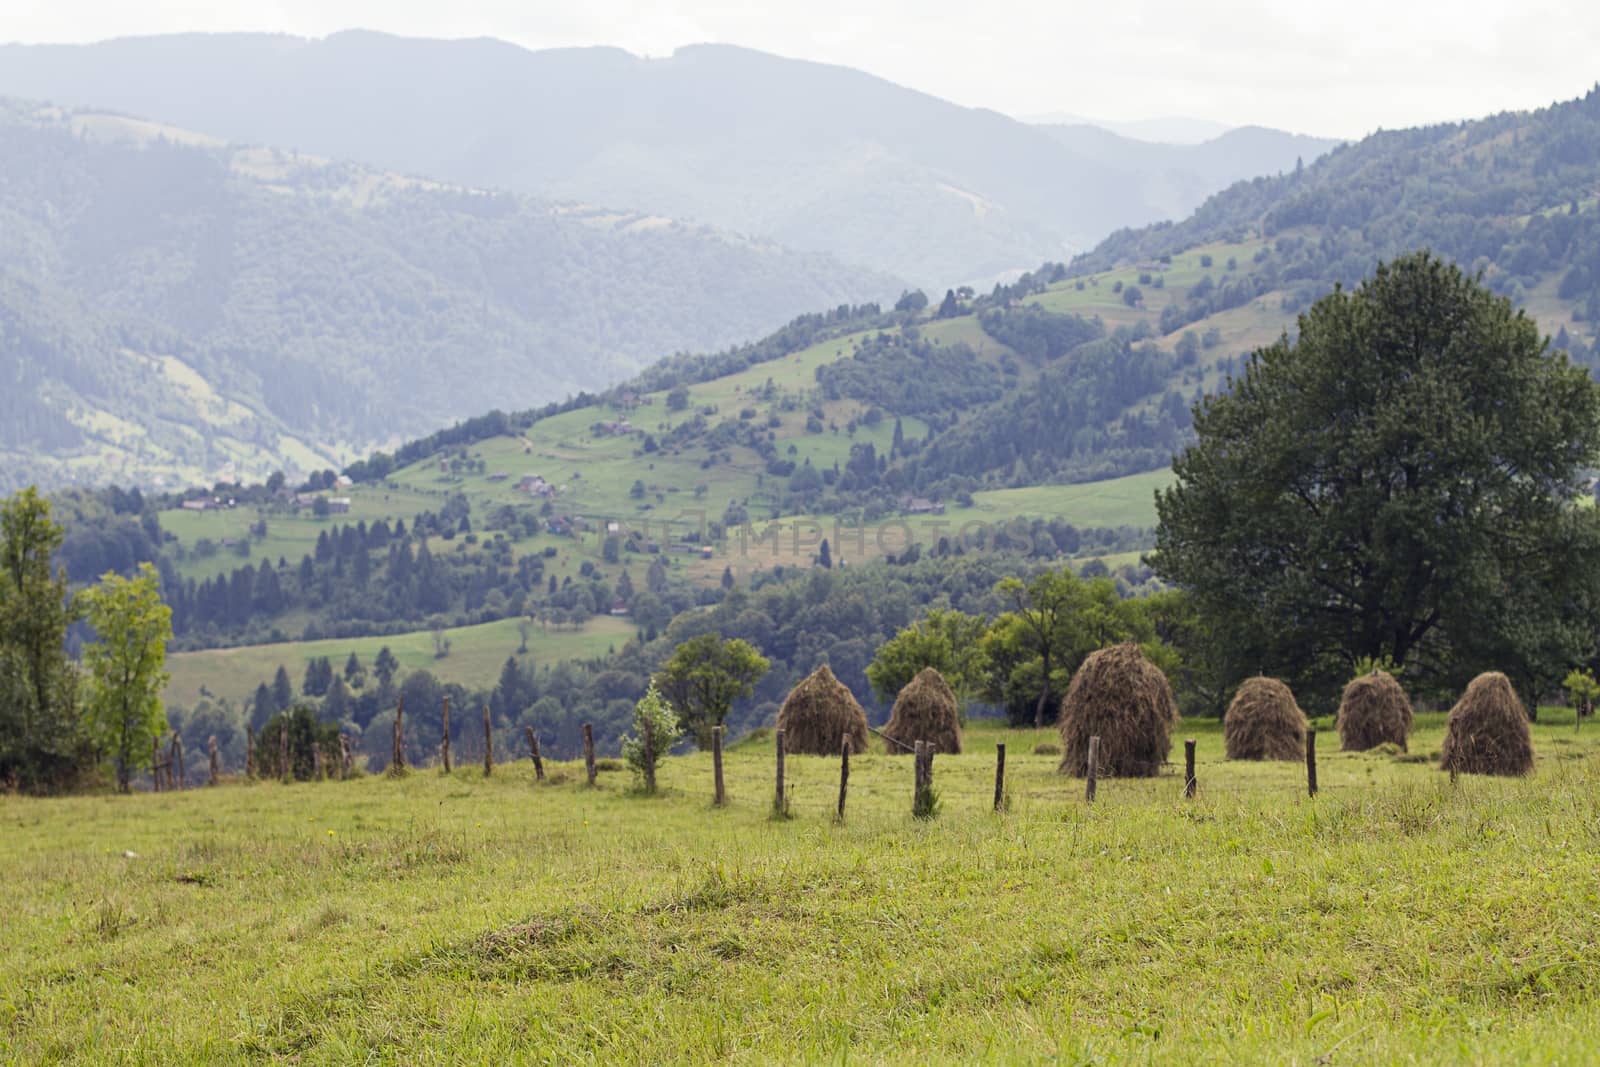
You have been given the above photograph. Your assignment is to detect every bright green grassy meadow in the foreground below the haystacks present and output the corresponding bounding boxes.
[0,712,1600,1065]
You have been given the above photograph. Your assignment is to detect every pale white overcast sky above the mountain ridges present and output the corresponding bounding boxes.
[0,0,1600,138]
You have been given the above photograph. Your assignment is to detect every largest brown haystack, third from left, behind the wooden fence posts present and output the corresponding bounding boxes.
[1061,643,1178,777]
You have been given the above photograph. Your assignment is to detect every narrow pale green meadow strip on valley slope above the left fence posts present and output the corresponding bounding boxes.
[163,616,634,705]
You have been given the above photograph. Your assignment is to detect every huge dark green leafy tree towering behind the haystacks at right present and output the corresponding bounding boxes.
[1152,253,1600,700]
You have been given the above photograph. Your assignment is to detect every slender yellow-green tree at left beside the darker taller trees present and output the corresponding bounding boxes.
[83,563,173,792]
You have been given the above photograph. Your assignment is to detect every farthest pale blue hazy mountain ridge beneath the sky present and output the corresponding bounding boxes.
[0,32,1331,286]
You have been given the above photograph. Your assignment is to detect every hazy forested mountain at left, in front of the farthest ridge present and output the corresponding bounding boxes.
[0,101,899,491]
